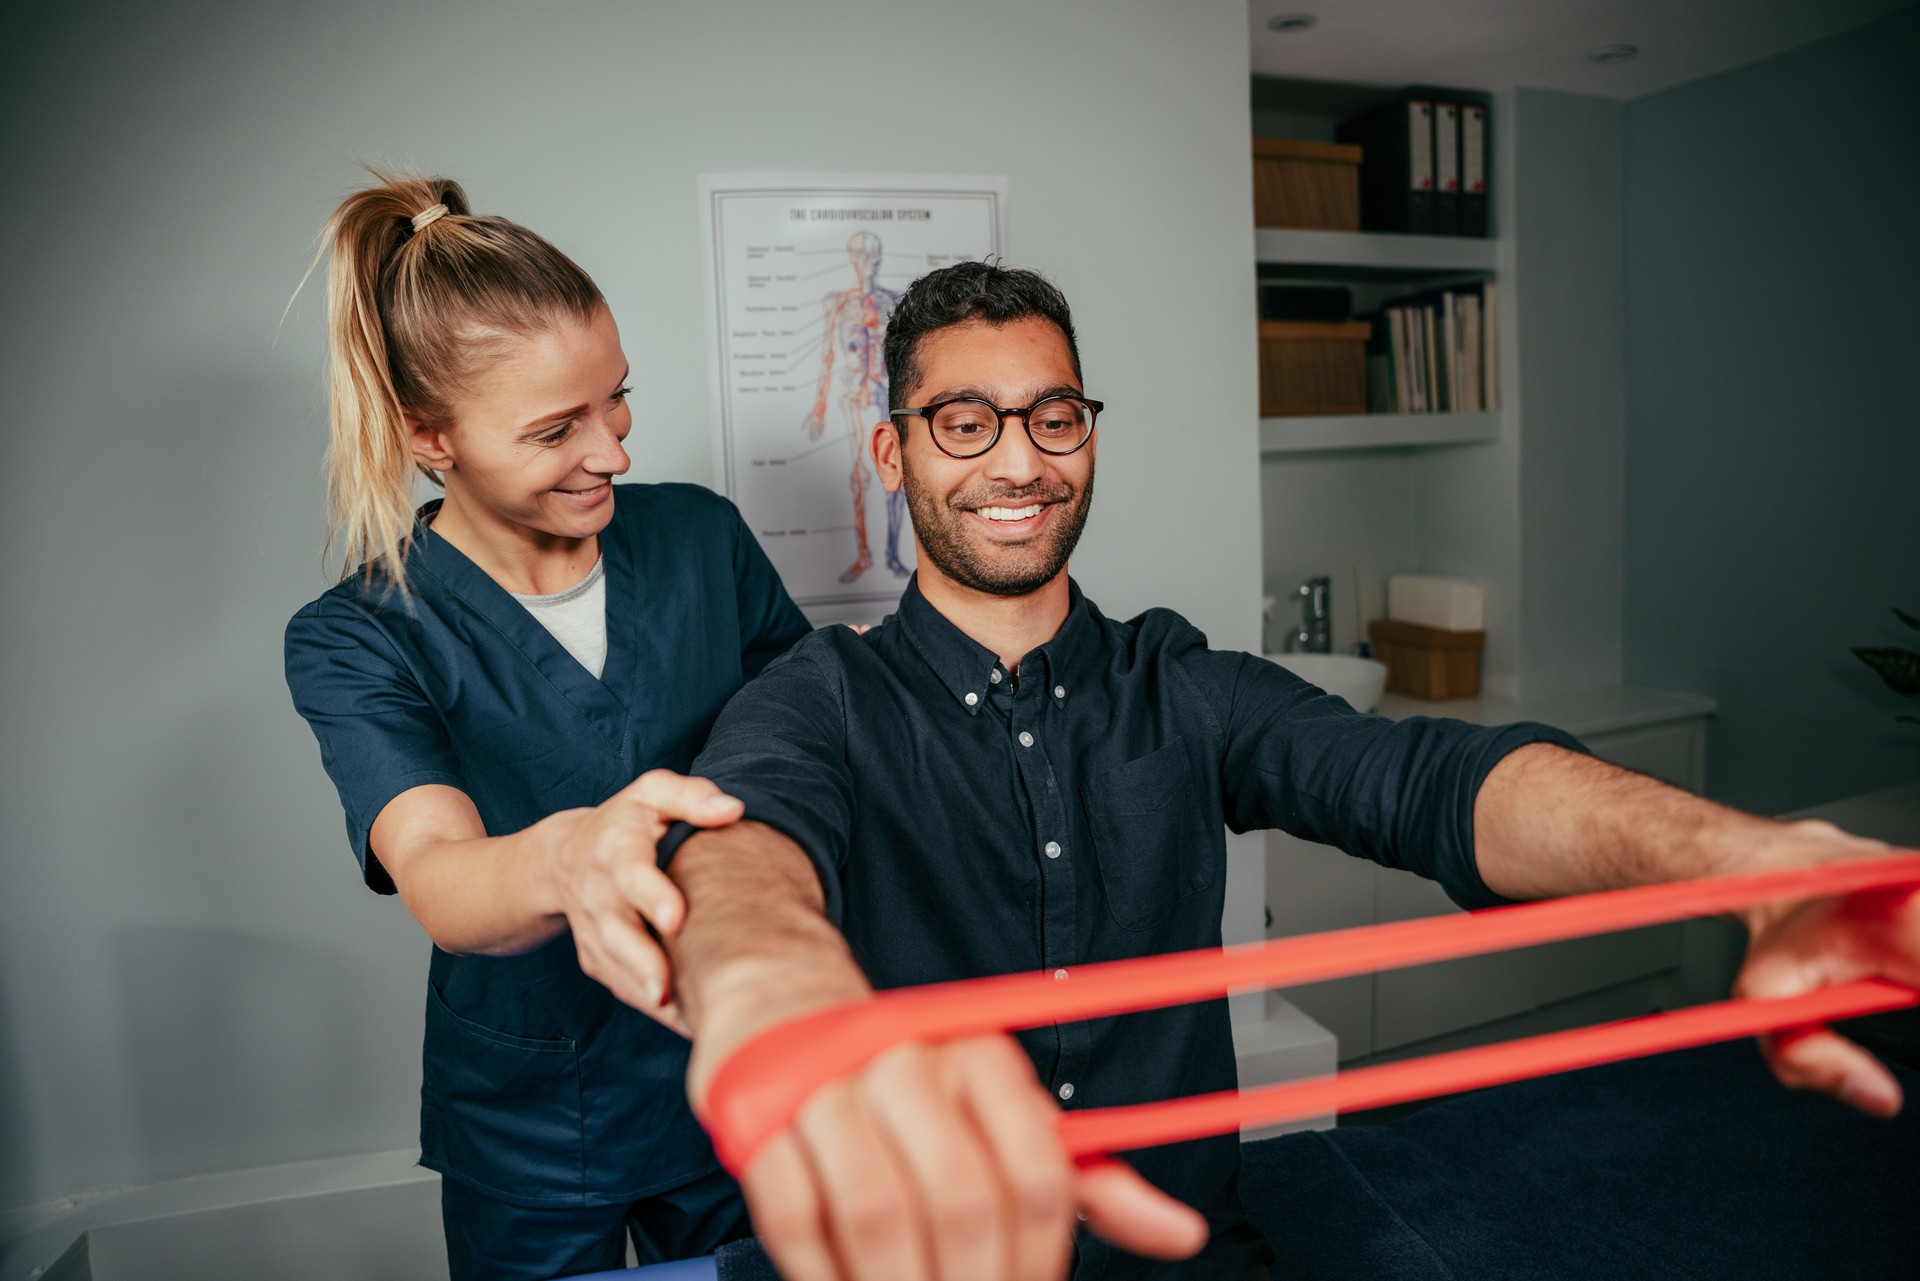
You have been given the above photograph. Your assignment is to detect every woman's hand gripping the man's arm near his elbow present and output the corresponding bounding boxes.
[536,770,743,1035]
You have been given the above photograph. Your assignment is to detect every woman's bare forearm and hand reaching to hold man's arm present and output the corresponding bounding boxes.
[369,770,741,1026]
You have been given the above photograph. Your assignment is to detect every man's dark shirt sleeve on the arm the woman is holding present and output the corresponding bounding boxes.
[659,634,852,926]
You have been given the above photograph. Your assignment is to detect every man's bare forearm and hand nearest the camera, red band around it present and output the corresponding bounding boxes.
[670,822,1206,1281]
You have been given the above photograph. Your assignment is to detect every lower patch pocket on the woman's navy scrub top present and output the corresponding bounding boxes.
[420,985,586,1206]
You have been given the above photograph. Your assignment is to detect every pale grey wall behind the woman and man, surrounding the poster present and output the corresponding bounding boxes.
[0,0,1260,1208]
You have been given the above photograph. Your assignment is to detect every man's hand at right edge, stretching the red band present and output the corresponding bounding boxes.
[1734,822,1920,1116]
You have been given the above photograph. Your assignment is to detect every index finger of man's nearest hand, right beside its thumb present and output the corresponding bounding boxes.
[947,1037,1073,1281]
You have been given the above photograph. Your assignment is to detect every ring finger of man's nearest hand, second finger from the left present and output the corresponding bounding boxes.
[795,1081,931,1281]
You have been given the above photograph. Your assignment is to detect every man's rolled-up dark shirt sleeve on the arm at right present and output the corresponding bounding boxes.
[1183,649,1586,908]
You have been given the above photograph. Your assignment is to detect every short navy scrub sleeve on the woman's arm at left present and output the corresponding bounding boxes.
[286,603,467,895]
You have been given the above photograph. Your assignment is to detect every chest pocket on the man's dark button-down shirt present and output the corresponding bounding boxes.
[1085,739,1217,930]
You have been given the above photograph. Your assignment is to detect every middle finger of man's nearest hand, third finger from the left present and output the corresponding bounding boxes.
[856,1045,1006,1281]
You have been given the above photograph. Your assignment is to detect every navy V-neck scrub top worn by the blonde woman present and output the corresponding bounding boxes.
[286,484,808,1206]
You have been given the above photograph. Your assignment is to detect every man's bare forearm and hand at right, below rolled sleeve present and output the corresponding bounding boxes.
[1473,743,1920,1116]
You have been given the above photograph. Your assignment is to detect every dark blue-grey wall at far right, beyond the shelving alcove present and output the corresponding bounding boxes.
[1624,10,1920,812]
